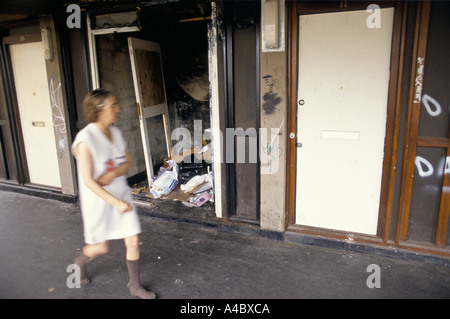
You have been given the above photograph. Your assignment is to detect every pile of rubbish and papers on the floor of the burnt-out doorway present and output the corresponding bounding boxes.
[132,146,214,207]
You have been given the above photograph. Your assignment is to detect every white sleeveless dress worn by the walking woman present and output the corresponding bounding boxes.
[72,123,141,244]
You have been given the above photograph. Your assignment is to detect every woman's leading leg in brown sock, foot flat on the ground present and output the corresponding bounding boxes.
[125,235,156,299]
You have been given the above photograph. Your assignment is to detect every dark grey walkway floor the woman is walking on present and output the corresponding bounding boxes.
[0,191,450,299]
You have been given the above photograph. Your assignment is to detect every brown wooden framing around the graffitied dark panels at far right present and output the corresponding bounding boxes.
[395,1,450,250]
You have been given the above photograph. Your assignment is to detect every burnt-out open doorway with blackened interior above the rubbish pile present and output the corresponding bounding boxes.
[88,3,220,213]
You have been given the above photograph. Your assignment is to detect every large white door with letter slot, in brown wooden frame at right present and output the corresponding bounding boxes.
[295,8,394,234]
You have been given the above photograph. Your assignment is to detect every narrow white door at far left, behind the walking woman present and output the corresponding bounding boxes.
[9,42,61,188]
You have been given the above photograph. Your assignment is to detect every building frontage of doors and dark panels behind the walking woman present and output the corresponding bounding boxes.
[0,0,450,257]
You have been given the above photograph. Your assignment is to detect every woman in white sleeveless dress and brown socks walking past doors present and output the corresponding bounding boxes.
[72,89,156,299]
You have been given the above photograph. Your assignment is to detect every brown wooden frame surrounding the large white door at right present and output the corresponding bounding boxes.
[285,1,406,244]
